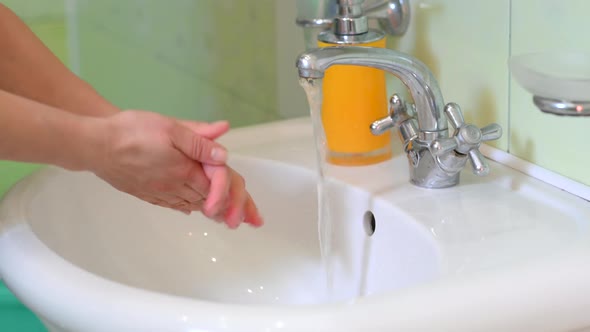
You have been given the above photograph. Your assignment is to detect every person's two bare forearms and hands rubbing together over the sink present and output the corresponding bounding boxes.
[0,4,262,227]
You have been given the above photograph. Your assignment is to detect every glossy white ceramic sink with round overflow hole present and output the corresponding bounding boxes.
[0,119,590,332]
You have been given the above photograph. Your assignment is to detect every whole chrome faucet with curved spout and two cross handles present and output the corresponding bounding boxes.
[297,46,502,188]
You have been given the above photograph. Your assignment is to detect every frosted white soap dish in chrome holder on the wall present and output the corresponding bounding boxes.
[510,52,590,116]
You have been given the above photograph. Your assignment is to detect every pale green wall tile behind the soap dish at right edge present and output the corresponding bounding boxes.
[510,0,590,185]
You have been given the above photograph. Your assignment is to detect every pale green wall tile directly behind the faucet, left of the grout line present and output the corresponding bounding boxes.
[388,0,510,150]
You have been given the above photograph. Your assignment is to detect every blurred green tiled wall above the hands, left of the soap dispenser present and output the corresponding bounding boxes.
[77,0,280,127]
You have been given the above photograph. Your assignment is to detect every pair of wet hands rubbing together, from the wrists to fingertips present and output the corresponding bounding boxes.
[91,111,262,228]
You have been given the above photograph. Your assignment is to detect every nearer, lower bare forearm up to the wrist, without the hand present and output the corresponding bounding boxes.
[0,90,105,170]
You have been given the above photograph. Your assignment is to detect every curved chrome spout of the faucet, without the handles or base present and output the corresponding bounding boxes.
[297,46,448,136]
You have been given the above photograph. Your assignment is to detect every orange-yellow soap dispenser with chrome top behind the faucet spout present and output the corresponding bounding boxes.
[318,0,392,166]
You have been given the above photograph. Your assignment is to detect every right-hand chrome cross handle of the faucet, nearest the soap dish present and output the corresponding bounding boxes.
[429,103,502,176]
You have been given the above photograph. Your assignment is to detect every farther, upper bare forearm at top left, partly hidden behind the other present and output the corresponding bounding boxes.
[0,4,118,116]
